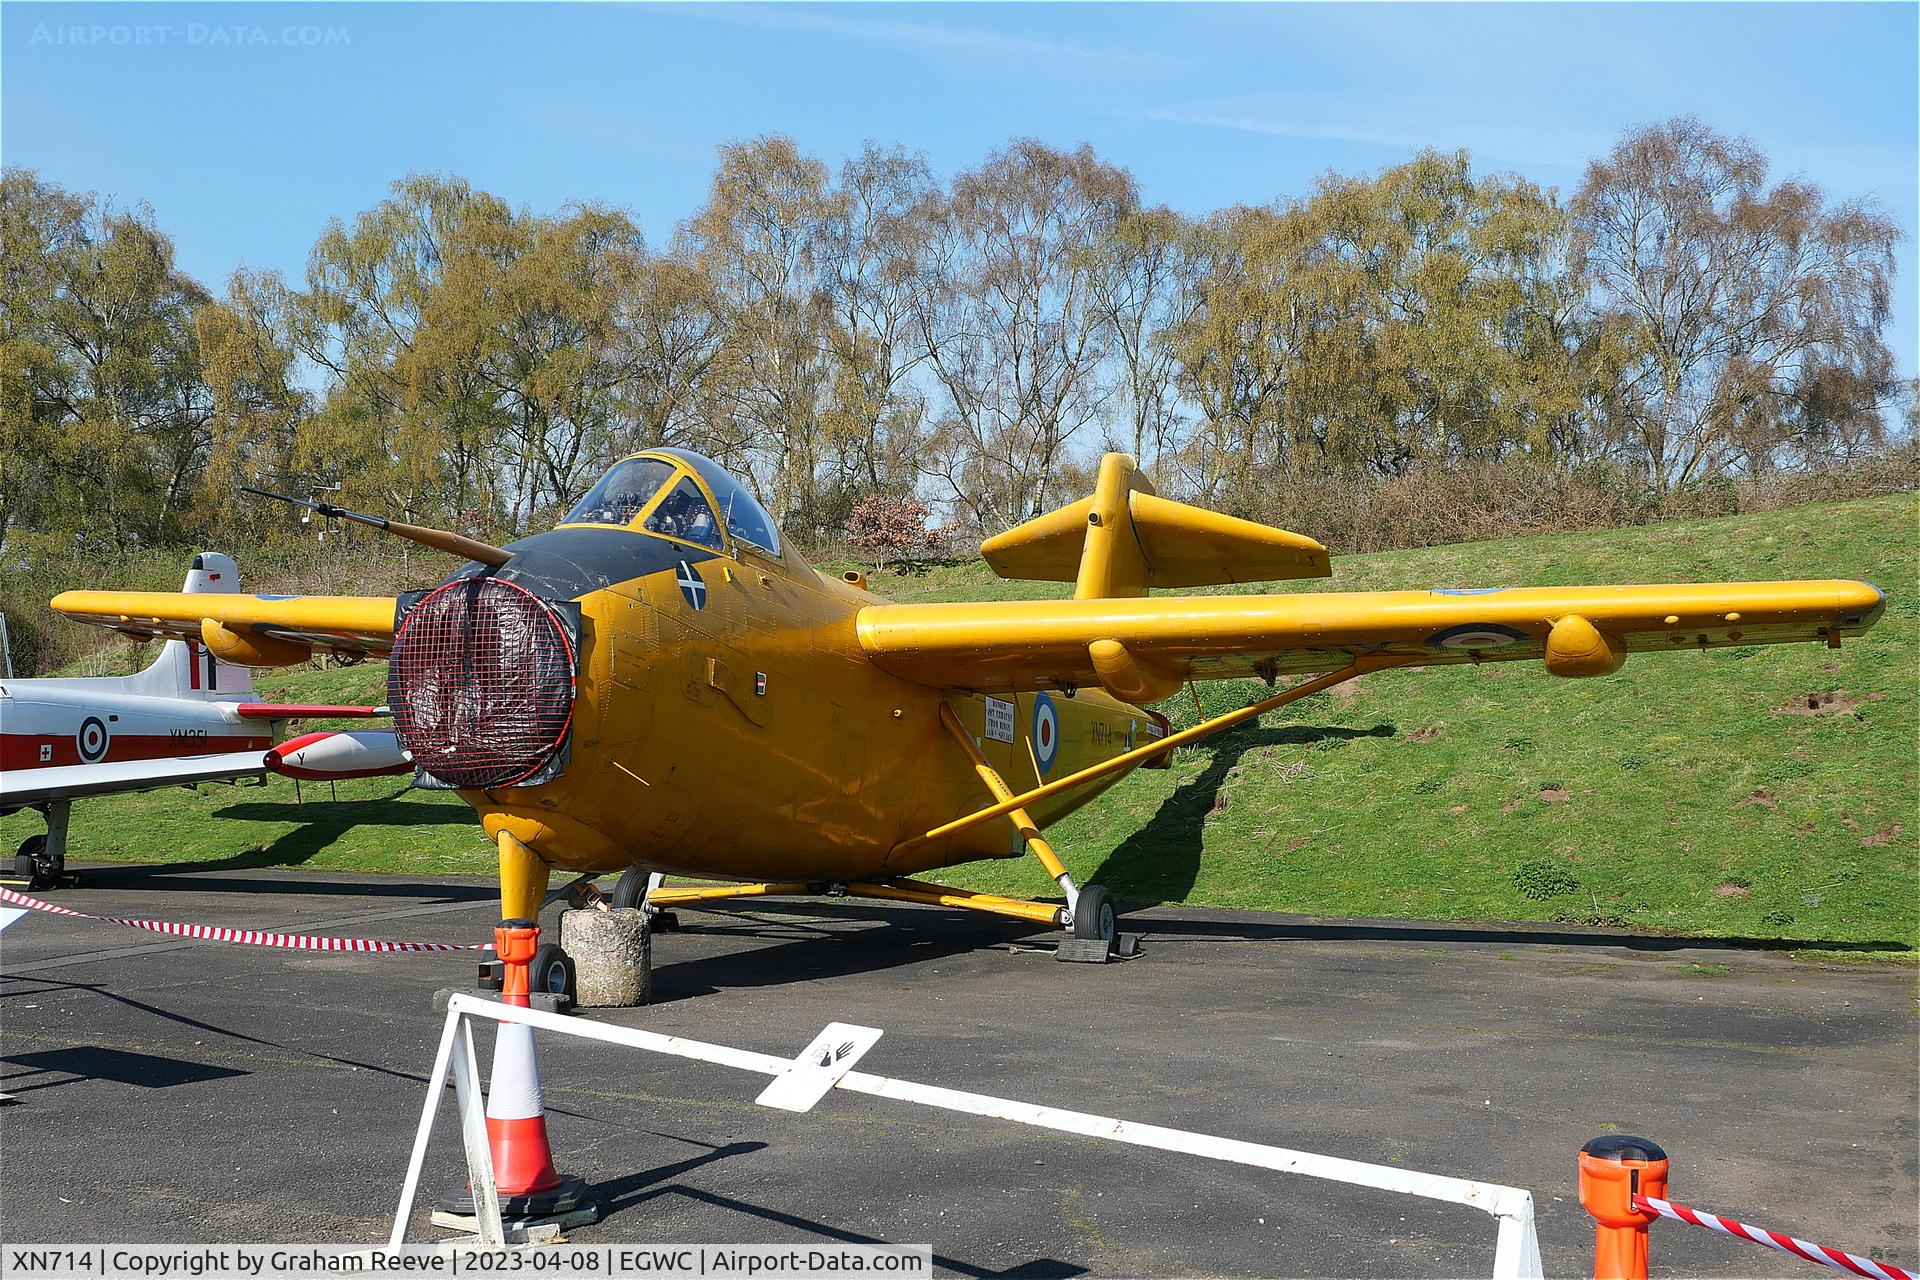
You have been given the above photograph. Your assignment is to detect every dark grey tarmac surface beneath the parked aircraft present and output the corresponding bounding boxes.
[0,867,1920,1276]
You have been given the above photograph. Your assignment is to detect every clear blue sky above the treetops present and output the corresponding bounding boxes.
[11,0,1920,376]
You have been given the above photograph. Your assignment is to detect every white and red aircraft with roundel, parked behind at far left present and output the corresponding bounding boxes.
[0,551,392,889]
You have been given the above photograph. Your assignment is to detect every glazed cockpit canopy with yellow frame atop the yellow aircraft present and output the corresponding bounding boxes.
[561,449,780,557]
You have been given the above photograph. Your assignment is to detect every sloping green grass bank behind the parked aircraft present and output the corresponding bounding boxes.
[0,495,1920,956]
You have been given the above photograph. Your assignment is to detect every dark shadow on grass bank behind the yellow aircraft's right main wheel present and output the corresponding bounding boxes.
[1089,723,1394,906]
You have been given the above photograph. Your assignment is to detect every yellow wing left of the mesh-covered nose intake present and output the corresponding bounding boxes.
[54,591,394,666]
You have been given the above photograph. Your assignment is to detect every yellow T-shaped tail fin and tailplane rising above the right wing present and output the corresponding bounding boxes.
[979,453,1332,601]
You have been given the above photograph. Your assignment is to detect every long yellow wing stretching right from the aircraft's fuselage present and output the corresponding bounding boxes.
[860,581,1884,702]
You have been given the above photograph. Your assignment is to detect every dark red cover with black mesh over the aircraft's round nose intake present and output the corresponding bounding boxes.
[386,578,574,791]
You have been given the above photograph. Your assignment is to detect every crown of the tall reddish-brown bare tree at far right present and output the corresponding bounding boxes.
[1572,117,1899,491]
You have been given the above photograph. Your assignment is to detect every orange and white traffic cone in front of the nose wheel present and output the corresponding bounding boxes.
[440,919,586,1219]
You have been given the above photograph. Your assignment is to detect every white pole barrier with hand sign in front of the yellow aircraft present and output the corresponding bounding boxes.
[401,996,1542,1280]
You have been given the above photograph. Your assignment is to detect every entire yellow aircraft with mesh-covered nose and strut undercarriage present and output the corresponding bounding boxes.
[54,449,1884,988]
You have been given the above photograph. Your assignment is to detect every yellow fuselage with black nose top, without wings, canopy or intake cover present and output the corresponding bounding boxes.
[416,526,1158,883]
